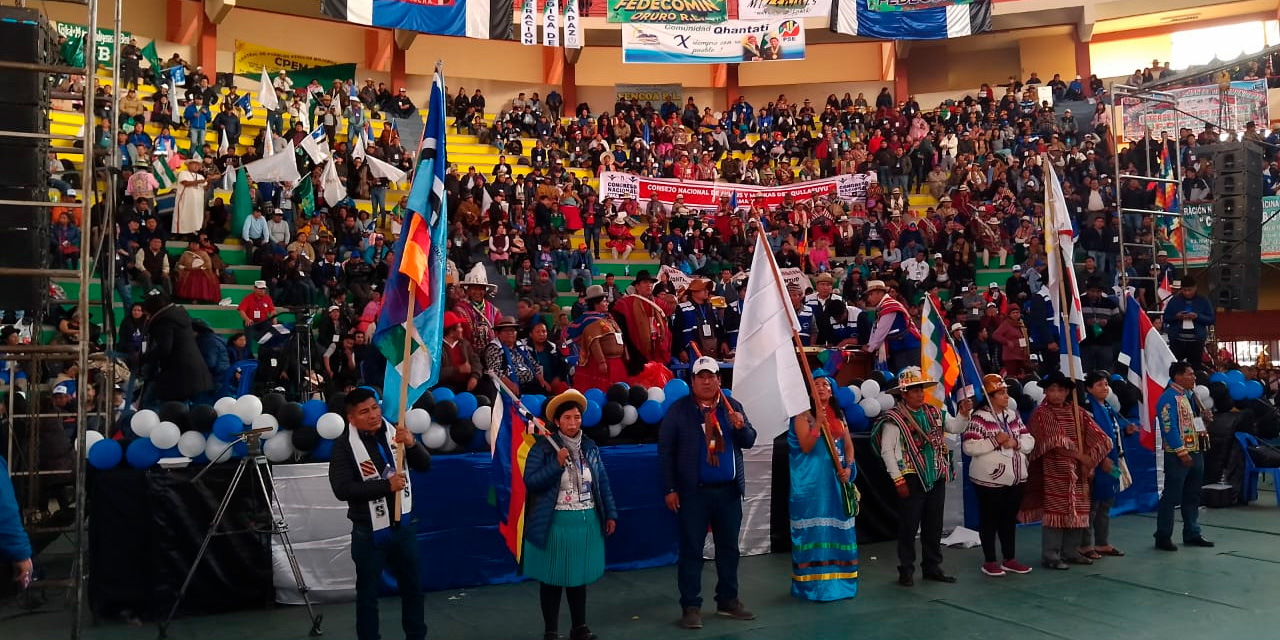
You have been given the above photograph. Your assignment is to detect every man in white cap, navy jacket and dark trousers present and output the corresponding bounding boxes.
[658,356,755,628]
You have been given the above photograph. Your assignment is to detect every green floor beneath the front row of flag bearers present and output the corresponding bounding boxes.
[10,492,1280,640]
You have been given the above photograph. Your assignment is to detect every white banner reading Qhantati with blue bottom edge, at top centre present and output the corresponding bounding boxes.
[622,18,805,64]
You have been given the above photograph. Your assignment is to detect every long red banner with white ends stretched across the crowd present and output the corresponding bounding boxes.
[600,172,870,212]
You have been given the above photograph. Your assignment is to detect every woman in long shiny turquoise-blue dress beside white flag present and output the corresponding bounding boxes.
[787,376,858,602]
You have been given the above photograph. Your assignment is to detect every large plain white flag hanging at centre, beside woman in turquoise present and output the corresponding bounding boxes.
[733,233,809,443]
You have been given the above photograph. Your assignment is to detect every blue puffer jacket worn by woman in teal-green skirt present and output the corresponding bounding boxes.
[525,434,618,549]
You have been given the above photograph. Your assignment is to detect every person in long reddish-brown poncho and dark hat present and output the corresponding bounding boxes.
[1019,371,1111,570]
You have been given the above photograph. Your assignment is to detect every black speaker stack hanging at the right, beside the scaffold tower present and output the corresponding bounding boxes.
[1197,141,1265,311]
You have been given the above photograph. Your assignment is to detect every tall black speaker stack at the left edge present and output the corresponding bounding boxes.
[0,6,58,310]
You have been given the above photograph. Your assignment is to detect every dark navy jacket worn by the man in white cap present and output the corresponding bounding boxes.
[658,396,755,495]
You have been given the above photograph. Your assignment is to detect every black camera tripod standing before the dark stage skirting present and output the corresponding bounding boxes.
[159,429,324,640]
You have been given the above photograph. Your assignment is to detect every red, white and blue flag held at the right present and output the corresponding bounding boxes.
[1116,293,1175,451]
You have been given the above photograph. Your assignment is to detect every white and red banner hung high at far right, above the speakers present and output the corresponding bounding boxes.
[1121,79,1270,140]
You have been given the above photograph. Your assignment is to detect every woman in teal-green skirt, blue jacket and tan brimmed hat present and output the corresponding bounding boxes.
[521,390,618,640]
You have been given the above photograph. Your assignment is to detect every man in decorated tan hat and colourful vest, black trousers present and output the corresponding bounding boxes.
[872,366,973,586]
